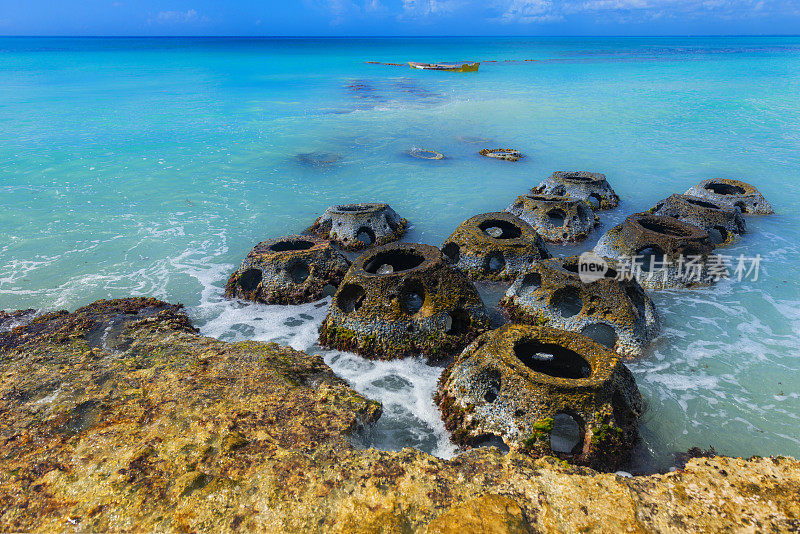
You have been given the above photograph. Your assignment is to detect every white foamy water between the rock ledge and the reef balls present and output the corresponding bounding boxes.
[189,264,458,458]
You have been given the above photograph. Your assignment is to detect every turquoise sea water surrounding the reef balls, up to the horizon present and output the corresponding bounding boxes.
[0,37,800,467]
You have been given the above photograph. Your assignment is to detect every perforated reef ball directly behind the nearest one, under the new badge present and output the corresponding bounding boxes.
[500,256,660,359]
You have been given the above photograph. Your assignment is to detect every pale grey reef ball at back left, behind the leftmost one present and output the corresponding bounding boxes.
[309,203,408,250]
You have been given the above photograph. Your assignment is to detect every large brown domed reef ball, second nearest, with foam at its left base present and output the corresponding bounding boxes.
[319,243,489,359]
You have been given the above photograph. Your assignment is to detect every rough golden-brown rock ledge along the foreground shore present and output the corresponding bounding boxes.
[0,299,800,532]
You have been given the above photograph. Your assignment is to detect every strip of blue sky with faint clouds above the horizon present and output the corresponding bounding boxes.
[0,0,800,36]
